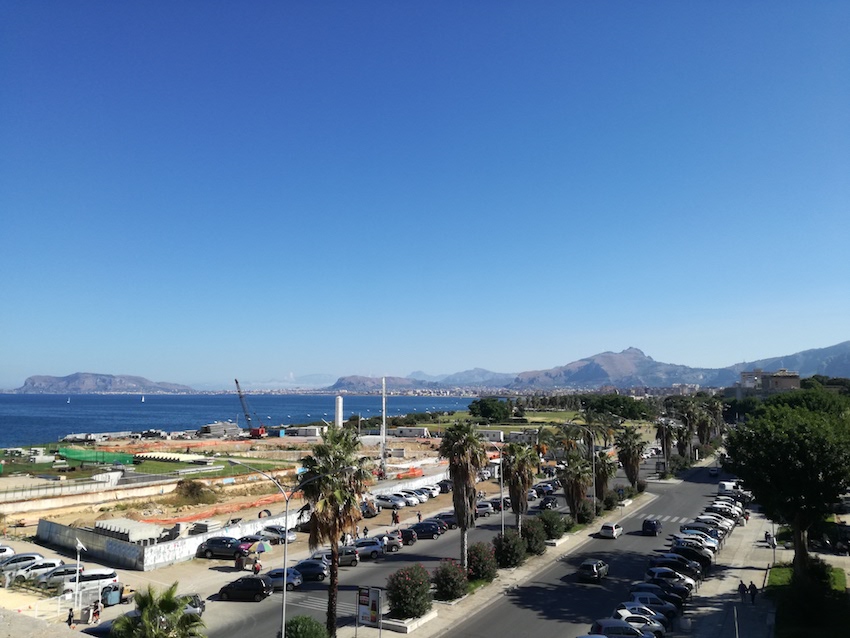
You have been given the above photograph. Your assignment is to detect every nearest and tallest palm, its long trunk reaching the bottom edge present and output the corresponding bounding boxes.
[301,424,372,638]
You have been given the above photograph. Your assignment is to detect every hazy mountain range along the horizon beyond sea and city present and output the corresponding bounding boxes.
[13,341,850,394]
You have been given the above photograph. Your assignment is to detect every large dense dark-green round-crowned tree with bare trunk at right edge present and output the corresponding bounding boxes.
[726,406,850,582]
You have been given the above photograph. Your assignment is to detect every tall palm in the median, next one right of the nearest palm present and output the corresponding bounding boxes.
[440,423,487,572]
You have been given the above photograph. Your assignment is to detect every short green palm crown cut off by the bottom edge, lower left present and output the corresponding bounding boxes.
[109,582,204,638]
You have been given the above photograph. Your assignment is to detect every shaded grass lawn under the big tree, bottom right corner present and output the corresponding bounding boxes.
[767,564,850,638]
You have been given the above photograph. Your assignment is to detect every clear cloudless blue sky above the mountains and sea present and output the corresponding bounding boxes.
[0,0,850,388]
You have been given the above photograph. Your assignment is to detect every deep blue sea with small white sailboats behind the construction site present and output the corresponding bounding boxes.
[0,394,474,448]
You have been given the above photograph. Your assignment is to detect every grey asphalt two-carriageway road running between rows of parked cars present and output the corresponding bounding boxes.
[204,460,716,638]
